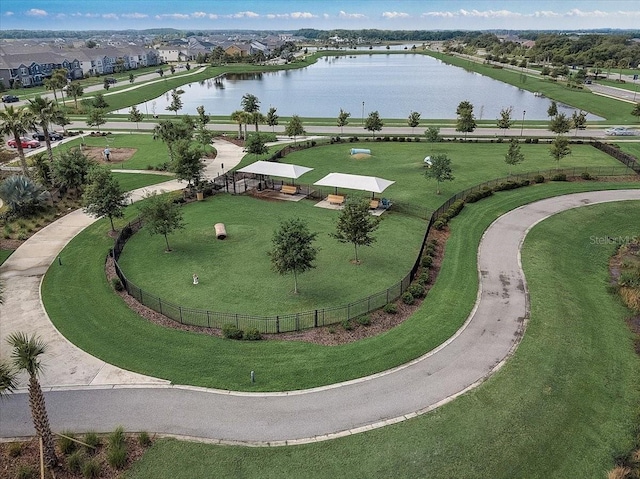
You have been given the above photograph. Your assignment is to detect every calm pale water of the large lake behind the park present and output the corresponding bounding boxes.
[120,53,595,121]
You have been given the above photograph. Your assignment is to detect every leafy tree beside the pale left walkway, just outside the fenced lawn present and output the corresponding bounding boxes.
[83,167,129,231]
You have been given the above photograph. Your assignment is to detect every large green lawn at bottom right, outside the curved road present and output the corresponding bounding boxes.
[126,198,640,479]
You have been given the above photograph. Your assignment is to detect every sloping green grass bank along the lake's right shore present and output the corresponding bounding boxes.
[427,51,637,124]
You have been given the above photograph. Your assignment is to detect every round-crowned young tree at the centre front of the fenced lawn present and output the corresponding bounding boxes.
[269,218,318,294]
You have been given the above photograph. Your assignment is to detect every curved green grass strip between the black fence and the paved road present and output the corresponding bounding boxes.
[42,182,638,391]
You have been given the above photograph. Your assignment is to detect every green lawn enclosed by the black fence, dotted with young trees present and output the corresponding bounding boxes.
[120,195,425,317]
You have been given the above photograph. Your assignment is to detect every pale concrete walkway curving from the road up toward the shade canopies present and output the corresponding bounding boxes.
[0,140,244,387]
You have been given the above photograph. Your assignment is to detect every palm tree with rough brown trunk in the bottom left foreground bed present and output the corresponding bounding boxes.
[7,332,58,469]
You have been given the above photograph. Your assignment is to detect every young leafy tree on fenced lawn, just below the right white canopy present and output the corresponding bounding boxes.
[330,199,380,264]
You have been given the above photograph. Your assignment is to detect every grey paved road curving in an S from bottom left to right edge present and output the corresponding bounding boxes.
[0,190,640,445]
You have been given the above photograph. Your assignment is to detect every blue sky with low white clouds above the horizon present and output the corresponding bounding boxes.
[0,0,640,30]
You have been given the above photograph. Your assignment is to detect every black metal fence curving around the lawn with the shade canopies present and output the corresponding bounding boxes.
[111,141,640,333]
